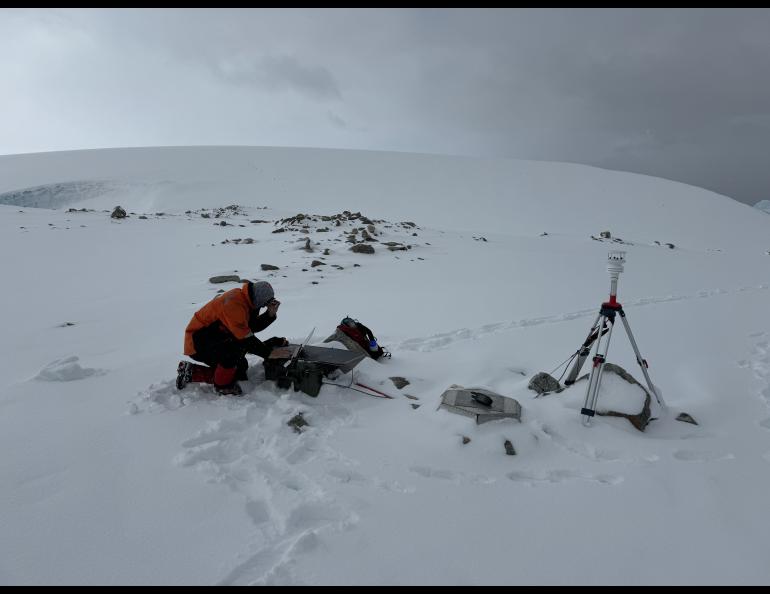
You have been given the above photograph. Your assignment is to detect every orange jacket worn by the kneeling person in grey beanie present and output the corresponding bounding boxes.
[184,283,254,356]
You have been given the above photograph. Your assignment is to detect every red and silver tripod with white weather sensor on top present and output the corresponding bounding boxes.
[564,252,666,426]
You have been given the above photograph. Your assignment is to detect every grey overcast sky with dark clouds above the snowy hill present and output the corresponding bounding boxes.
[0,8,770,204]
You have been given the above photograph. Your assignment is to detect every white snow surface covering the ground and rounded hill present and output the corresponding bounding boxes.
[0,147,770,585]
